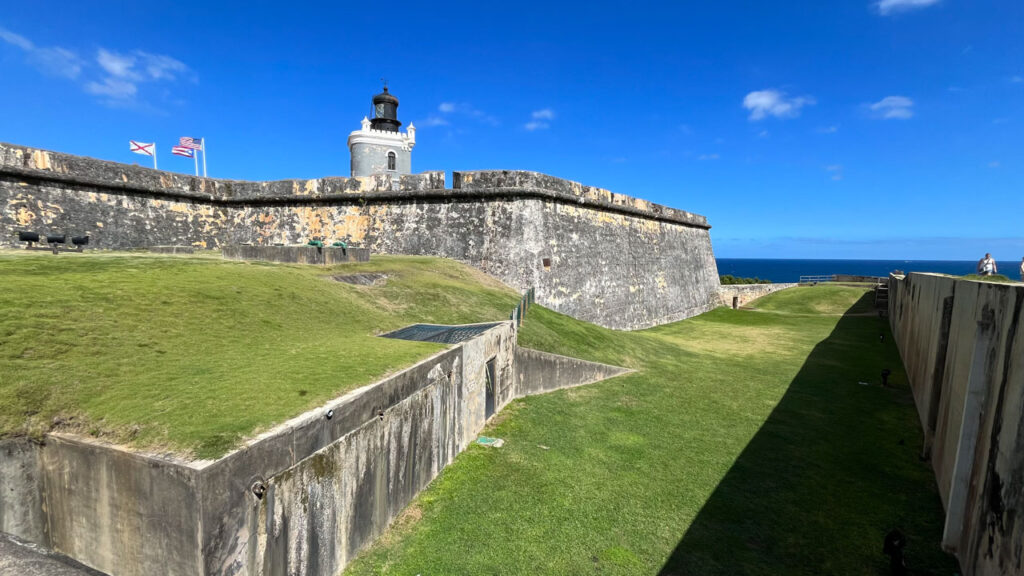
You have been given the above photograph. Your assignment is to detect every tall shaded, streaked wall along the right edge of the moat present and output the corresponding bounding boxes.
[889,274,1024,576]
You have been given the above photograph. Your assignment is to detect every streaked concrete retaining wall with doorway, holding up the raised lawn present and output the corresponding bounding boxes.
[0,322,625,576]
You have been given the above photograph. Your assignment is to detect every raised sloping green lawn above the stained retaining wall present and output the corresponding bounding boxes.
[0,251,518,458]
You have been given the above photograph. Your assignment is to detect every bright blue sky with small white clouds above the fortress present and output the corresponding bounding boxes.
[0,0,1024,261]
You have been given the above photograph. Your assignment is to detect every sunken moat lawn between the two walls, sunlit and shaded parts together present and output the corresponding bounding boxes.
[346,286,957,576]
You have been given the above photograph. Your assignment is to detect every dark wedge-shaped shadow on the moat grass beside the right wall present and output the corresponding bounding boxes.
[660,293,958,576]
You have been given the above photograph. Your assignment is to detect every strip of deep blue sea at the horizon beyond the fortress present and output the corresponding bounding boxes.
[717,258,983,282]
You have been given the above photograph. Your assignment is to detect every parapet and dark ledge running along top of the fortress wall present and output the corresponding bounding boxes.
[0,142,711,230]
